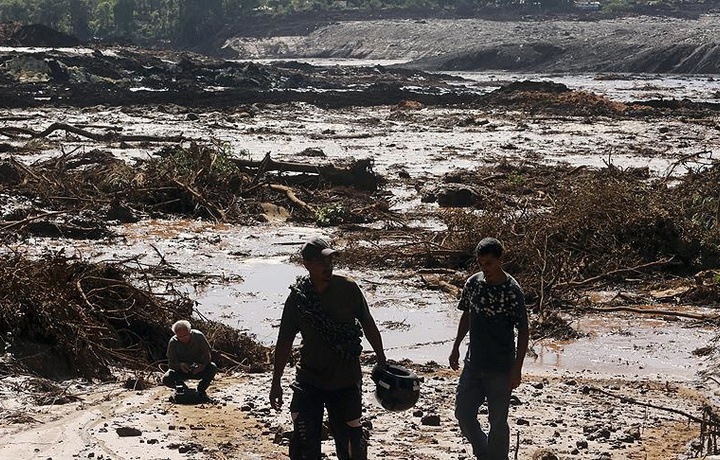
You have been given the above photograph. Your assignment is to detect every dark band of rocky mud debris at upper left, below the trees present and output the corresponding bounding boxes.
[0,47,472,109]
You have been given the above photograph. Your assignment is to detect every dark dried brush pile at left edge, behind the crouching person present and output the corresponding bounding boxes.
[0,254,267,379]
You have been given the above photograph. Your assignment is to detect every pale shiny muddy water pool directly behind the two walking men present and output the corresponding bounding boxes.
[188,252,713,380]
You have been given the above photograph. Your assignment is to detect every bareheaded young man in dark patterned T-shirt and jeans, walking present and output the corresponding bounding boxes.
[450,238,529,460]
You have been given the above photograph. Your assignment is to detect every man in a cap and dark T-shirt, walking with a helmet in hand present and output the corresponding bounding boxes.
[270,237,385,460]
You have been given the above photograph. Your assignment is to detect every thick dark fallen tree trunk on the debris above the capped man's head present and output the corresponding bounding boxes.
[232,154,380,190]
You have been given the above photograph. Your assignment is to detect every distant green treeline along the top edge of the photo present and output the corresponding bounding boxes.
[0,0,720,46]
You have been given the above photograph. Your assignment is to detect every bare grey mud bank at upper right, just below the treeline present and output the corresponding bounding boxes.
[217,14,720,74]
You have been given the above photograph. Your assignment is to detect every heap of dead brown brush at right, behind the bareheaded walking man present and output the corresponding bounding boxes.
[344,157,720,338]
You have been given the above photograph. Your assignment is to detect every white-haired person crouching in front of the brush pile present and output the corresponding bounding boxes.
[163,320,217,401]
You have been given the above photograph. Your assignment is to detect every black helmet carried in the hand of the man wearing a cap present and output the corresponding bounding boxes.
[371,364,421,411]
